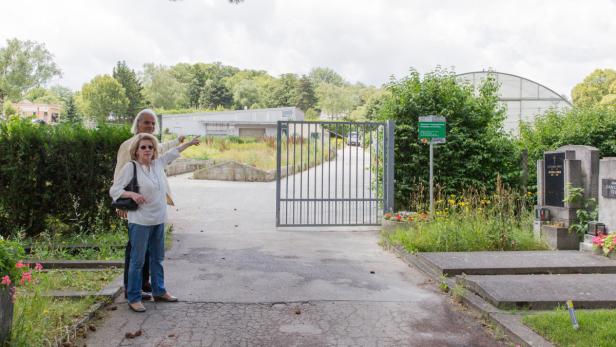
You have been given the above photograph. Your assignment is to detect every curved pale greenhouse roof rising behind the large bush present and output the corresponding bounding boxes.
[456,71,571,135]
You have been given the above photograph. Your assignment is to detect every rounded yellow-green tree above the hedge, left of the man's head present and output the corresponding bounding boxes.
[80,75,129,122]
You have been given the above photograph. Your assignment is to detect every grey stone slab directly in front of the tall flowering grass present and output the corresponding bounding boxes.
[417,251,616,276]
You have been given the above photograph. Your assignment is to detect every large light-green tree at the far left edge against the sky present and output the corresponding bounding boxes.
[0,39,61,103]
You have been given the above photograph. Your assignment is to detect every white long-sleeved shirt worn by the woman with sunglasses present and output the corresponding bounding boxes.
[109,148,180,225]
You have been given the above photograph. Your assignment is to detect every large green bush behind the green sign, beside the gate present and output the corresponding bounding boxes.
[379,69,520,210]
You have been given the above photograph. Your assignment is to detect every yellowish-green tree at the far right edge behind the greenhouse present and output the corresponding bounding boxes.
[571,69,616,106]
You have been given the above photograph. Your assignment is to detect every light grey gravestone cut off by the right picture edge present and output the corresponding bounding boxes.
[598,157,616,233]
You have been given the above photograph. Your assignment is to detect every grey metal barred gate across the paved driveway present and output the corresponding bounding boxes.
[276,121,394,227]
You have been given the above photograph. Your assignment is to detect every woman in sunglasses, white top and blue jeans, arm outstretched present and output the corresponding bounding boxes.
[109,134,199,312]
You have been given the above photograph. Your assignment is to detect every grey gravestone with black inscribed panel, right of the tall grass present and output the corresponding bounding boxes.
[535,145,599,249]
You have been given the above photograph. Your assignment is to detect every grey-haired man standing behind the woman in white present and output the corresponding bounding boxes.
[113,108,184,300]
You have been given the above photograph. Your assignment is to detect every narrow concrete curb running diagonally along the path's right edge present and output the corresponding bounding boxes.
[384,243,554,347]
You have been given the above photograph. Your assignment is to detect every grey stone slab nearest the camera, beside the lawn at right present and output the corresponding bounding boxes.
[457,274,616,309]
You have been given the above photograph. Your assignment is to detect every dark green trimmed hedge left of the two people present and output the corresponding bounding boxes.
[0,119,131,236]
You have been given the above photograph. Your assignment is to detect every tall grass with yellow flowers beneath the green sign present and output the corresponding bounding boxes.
[383,178,547,252]
